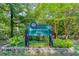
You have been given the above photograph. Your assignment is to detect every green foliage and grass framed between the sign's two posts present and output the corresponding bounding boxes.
[29,36,49,47]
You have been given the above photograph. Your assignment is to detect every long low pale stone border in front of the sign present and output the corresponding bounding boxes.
[0,44,75,55]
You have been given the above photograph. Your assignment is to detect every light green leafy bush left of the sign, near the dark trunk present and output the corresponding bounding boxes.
[9,36,24,46]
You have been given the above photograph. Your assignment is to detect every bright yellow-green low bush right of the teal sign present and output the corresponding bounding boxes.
[53,39,73,48]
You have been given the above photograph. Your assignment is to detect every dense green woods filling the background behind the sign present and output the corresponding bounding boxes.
[0,3,79,40]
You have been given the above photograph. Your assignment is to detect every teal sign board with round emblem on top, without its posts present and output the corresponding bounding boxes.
[28,23,51,36]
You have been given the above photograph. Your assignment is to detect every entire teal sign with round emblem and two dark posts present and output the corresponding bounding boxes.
[25,23,53,47]
